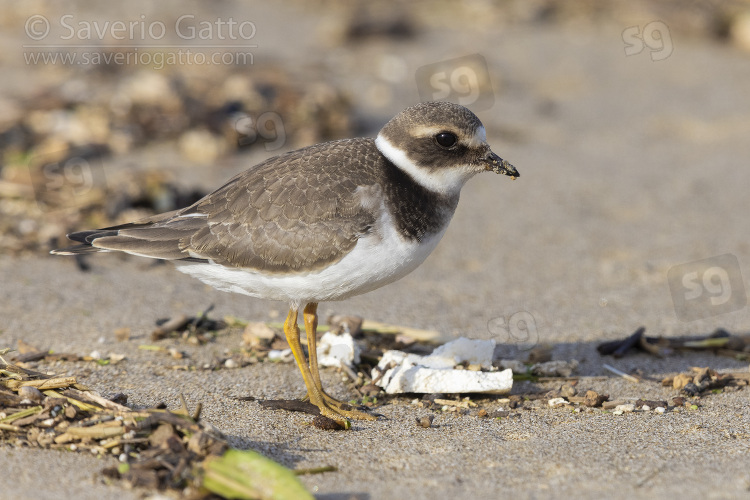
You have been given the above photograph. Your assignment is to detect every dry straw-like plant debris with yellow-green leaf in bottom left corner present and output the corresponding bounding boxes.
[0,356,312,500]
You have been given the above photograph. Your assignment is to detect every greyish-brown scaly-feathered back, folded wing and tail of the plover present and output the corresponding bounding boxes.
[56,139,382,273]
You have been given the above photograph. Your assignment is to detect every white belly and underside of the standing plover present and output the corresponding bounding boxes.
[177,210,448,307]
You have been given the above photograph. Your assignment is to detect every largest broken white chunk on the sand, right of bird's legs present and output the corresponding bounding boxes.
[372,337,513,394]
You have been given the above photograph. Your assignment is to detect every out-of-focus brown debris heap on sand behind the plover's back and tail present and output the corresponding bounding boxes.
[0,63,353,258]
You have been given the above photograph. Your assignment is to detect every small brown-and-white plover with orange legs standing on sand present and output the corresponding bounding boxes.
[52,102,518,428]
